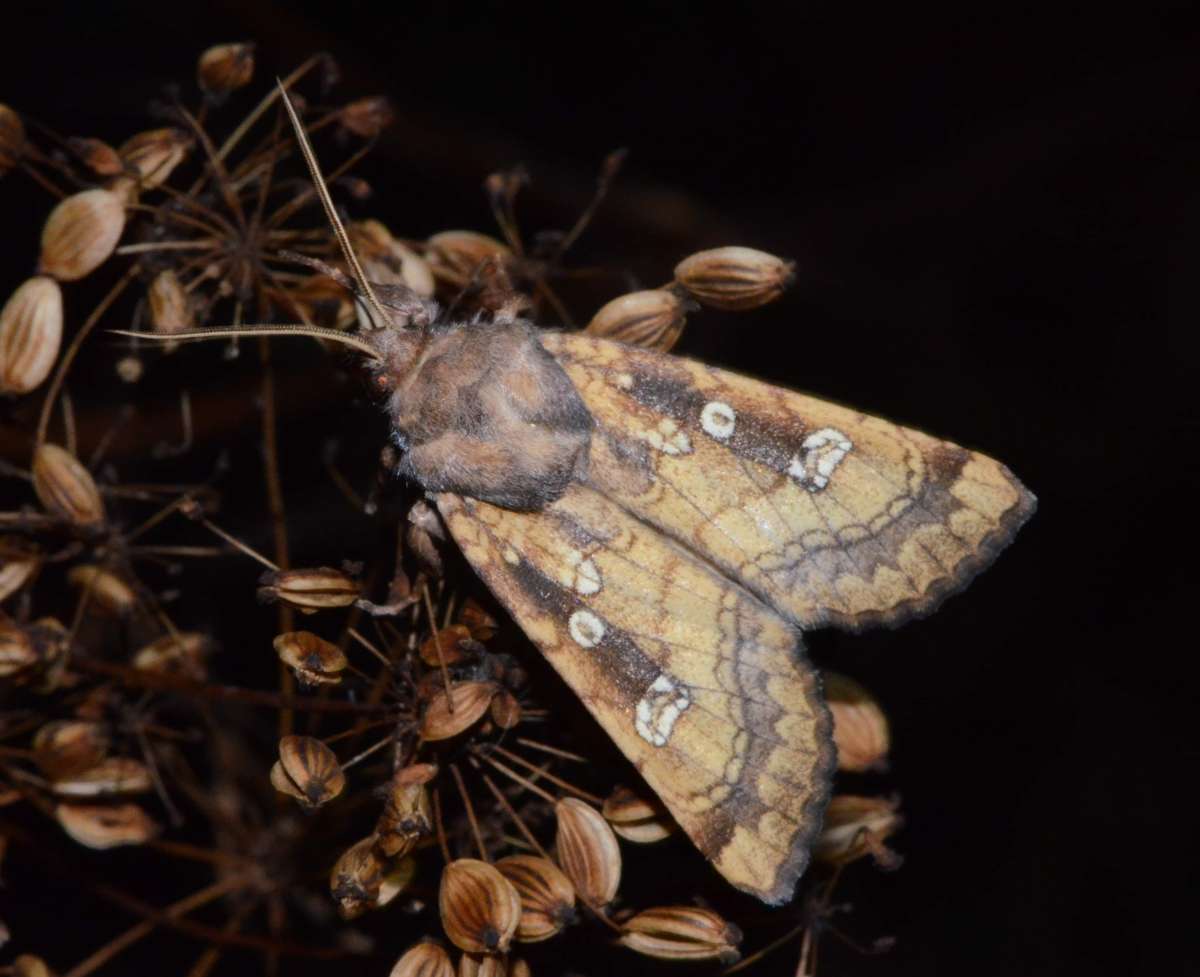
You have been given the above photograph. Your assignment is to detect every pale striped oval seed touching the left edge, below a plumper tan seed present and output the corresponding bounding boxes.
[0,275,62,395]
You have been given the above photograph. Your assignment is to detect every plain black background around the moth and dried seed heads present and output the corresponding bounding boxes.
[0,0,1180,975]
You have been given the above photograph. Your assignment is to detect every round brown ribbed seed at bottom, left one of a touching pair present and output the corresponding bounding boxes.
[438,858,521,953]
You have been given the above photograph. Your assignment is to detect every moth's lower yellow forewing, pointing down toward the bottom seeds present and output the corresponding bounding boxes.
[438,485,835,903]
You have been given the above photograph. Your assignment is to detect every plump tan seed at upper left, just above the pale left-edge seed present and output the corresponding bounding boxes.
[37,190,125,282]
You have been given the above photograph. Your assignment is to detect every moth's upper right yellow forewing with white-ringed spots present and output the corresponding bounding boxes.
[542,334,1036,629]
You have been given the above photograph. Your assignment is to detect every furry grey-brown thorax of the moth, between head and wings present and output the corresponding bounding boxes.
[376,318,593,510]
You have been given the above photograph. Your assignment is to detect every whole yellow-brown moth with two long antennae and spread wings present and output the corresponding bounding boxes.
[145,92,1036,904]
